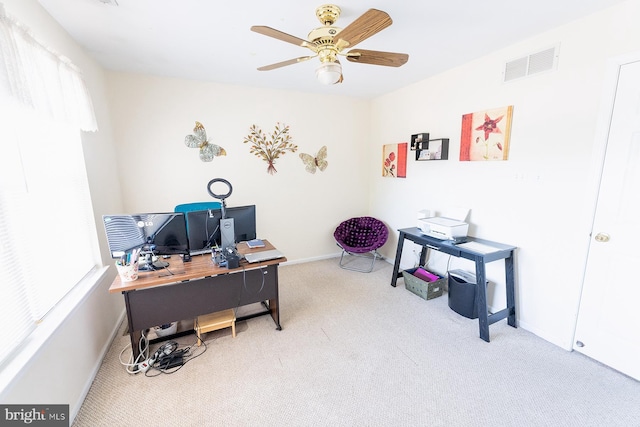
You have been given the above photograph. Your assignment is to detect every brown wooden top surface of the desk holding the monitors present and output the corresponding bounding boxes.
[109,239,287,293]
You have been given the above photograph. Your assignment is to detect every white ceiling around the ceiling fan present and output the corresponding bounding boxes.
[39,0,624,98]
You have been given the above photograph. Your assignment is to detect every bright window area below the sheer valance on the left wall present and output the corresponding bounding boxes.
[0,99,96,368]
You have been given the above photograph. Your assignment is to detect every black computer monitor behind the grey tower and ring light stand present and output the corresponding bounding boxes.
[186,205,256,255]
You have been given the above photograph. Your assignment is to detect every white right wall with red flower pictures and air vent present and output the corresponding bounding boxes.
[370,1,640,349]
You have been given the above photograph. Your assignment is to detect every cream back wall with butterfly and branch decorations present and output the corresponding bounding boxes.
[109,73,370,261]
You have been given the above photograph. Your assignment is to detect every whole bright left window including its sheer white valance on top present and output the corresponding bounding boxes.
[0,4,97,365]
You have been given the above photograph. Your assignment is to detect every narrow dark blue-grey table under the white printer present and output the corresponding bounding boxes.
[391,227,516,342]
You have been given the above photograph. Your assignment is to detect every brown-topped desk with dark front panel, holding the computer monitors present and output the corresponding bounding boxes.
[109,240,287,358]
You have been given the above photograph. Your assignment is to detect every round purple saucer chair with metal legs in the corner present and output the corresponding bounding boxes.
[333,216,389,273]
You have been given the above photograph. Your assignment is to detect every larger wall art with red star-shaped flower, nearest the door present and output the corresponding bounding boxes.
[460,105,513,161]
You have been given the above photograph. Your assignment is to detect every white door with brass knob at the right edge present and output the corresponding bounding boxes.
[573,57,640,380]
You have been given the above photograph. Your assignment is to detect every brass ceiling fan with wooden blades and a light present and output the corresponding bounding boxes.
[251,4,409,85]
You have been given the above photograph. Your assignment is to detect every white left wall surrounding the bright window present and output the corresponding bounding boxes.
[0,0,124,422]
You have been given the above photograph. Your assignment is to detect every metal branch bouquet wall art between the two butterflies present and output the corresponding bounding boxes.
[243,122,298,175]
